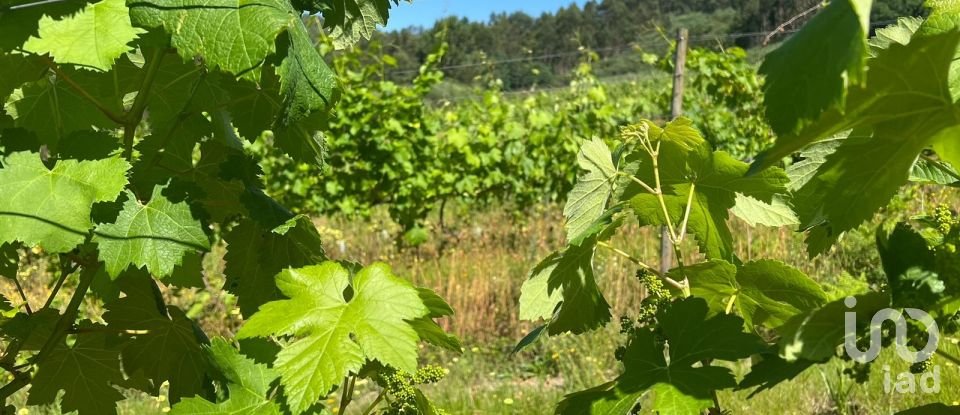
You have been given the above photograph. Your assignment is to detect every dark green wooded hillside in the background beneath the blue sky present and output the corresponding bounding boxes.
[381,0,924,89]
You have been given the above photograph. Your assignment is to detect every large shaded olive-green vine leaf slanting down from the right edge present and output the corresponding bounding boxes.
[794,32,960,256]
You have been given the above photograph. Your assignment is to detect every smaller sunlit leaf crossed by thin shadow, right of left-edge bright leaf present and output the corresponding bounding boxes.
[93,186,210,278]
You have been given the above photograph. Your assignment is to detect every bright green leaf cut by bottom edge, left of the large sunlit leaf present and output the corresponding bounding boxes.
[170,338,281,415]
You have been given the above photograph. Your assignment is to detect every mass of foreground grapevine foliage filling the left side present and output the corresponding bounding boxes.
[0,0,460,415]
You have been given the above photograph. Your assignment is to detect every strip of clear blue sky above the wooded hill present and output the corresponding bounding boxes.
[387,0,586,30]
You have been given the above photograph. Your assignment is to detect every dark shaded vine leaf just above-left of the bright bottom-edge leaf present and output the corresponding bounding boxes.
[103,273,210,403]
